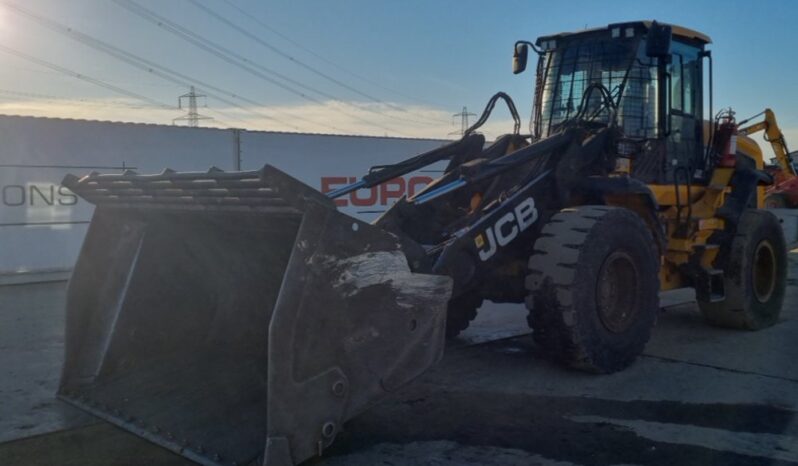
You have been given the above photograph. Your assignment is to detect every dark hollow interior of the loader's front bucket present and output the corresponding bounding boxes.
[60,209,301,464]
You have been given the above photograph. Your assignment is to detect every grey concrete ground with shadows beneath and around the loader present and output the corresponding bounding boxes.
[0,250,798,466]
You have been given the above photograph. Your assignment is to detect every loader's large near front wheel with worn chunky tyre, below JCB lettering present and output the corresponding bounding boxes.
[525,206,660,373]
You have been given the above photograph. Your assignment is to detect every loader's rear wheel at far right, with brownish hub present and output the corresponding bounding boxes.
[698,210,787,330]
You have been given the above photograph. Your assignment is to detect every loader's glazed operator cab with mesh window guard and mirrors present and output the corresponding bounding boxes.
[513,21,711,183]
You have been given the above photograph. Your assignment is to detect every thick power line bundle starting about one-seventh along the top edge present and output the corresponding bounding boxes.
[113,0,410,134]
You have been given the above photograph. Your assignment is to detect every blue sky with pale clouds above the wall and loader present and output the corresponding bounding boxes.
[0,0,798,140]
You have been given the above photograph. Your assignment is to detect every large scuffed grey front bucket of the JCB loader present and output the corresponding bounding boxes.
[59,166,451,466]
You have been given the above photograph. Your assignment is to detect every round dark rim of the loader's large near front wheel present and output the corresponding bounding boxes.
[596,251,639,333]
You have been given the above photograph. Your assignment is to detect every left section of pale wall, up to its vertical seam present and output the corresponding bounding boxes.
[0,116,237,274]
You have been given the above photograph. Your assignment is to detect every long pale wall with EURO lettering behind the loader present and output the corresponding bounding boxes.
[0,115,445,282]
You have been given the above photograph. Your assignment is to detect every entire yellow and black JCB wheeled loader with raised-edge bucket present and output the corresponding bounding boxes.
[59,21,786,466]
